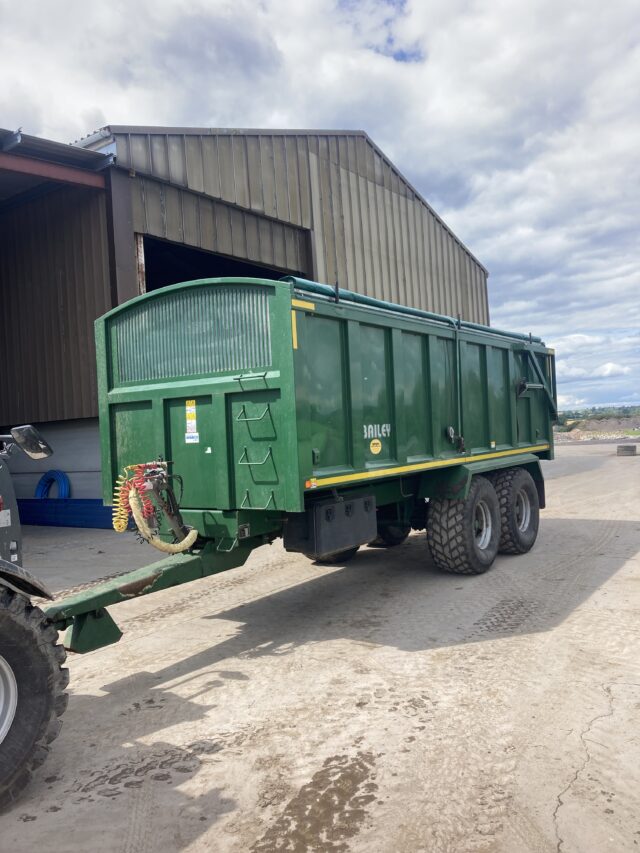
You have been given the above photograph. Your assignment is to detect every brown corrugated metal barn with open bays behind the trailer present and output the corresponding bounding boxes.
[0,125,489,510]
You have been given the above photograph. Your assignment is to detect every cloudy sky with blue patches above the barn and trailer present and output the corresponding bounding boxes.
[0,0,640,408]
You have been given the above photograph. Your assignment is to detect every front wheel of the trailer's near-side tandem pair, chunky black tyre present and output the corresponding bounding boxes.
[427,477,500,575]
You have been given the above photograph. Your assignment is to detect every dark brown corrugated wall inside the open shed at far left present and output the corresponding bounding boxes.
[0,187,111,425]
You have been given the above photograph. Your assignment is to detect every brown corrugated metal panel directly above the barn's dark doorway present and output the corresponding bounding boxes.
[131,176,311,275]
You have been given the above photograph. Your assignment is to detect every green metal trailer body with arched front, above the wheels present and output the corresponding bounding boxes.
[97,279,555,541]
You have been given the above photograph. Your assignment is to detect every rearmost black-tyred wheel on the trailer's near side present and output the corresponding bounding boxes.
[493,468,540,554]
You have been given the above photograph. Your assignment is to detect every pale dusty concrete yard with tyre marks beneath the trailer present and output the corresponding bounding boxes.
[0,444,640,853]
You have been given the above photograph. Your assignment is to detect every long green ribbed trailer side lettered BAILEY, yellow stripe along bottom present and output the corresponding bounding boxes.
[294,297,552,490]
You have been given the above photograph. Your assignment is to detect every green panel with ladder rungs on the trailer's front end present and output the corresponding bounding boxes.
[228,389,282,509]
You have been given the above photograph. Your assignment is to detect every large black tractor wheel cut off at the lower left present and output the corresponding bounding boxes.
[0,589,69,810]
